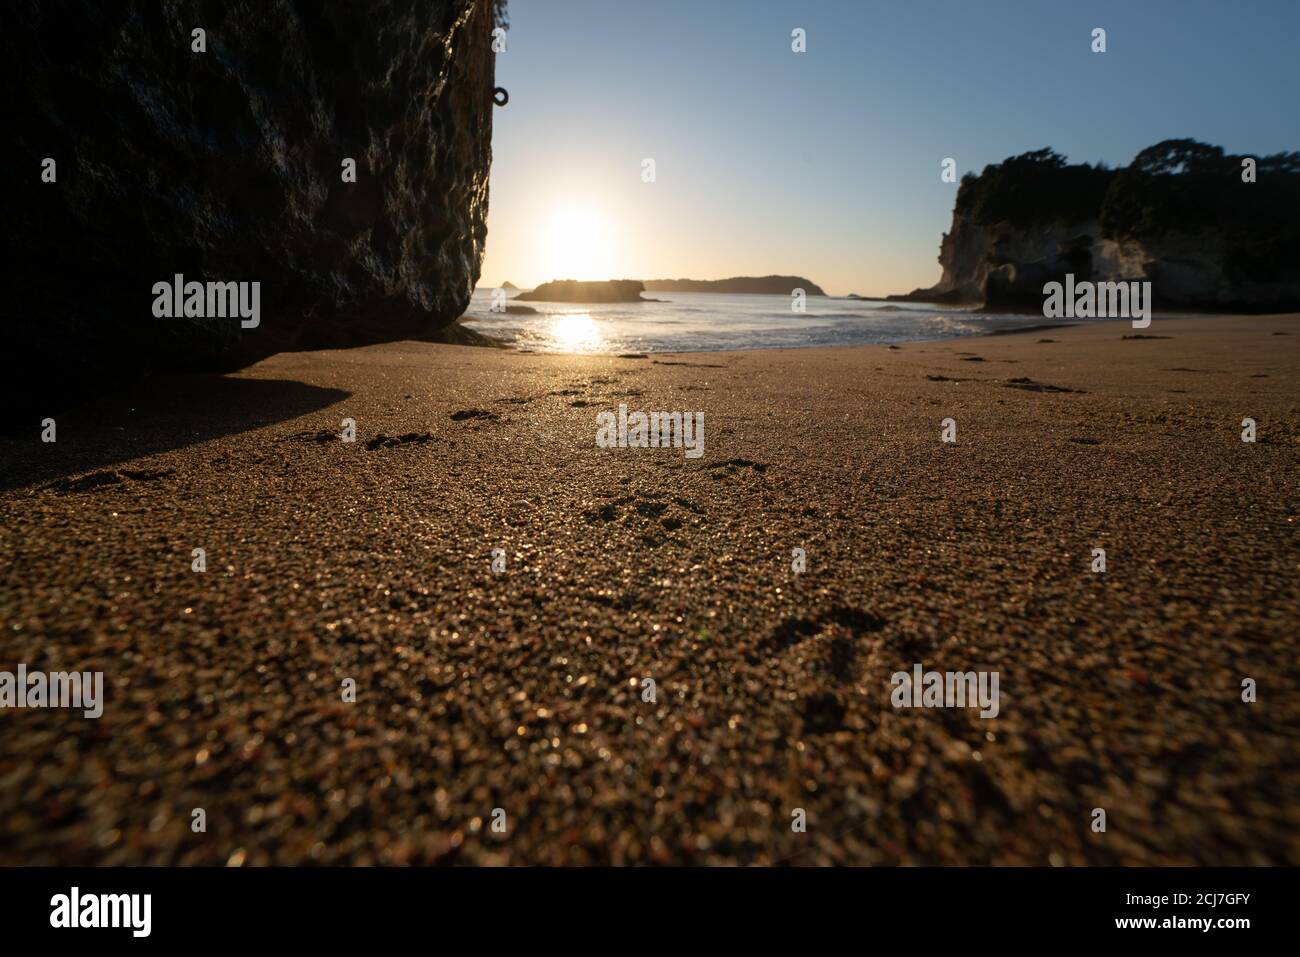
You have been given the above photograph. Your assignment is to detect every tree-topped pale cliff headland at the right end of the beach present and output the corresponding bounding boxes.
[889,139,1300,312]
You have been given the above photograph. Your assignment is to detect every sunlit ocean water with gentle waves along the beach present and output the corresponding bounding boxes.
[463,289,1071,354]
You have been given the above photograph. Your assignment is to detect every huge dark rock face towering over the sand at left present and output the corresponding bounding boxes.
[0,0,494,410]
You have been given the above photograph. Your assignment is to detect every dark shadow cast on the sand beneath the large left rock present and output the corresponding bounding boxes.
[0,374,351,492]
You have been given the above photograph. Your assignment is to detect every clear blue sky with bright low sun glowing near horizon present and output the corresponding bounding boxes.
[480,0,1300,295]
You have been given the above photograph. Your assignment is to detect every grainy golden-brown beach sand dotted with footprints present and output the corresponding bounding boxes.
[0,316,1300,865]
